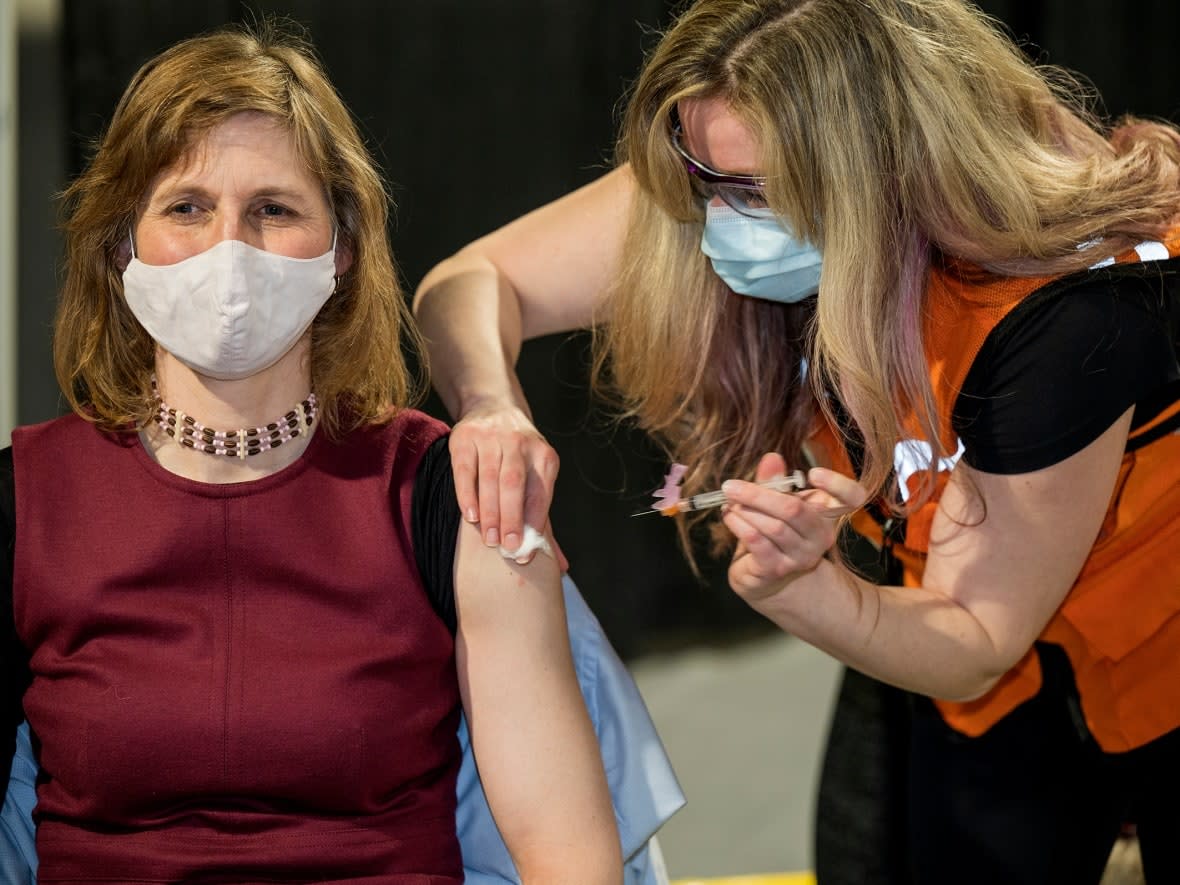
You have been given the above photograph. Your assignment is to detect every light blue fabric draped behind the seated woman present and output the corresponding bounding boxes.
[0,577,684,885]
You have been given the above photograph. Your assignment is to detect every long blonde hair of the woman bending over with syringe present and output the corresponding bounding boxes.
[596,0,1180,538]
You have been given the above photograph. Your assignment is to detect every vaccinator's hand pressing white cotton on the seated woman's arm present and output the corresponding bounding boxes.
[451,405,566,570]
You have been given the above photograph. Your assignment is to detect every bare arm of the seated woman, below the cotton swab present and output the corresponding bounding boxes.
[455,523,622,884]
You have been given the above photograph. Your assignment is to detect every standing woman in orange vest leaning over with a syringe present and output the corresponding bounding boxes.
[417,0,1180,883]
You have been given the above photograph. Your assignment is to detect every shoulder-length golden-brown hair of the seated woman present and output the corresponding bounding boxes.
[53,21,421,435]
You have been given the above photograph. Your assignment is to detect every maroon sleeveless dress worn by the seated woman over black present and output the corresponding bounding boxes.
[13,411,463,885]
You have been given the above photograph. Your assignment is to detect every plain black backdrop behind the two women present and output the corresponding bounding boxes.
[11,0,1180,657]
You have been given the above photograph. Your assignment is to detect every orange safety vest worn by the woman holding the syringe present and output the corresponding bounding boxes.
[817,229,1180,752]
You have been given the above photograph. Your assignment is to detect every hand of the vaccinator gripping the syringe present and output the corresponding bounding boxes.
[722,454,867,604]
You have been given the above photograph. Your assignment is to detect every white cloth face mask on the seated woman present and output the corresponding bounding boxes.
[123,236,336,381]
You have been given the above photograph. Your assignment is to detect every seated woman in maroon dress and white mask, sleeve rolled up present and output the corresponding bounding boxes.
[0,27,670,885]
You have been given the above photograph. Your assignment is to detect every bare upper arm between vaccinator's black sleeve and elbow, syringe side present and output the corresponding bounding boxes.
[923,409,1134,666]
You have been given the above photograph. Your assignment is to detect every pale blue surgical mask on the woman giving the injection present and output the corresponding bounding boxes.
[701,203,822,304]
